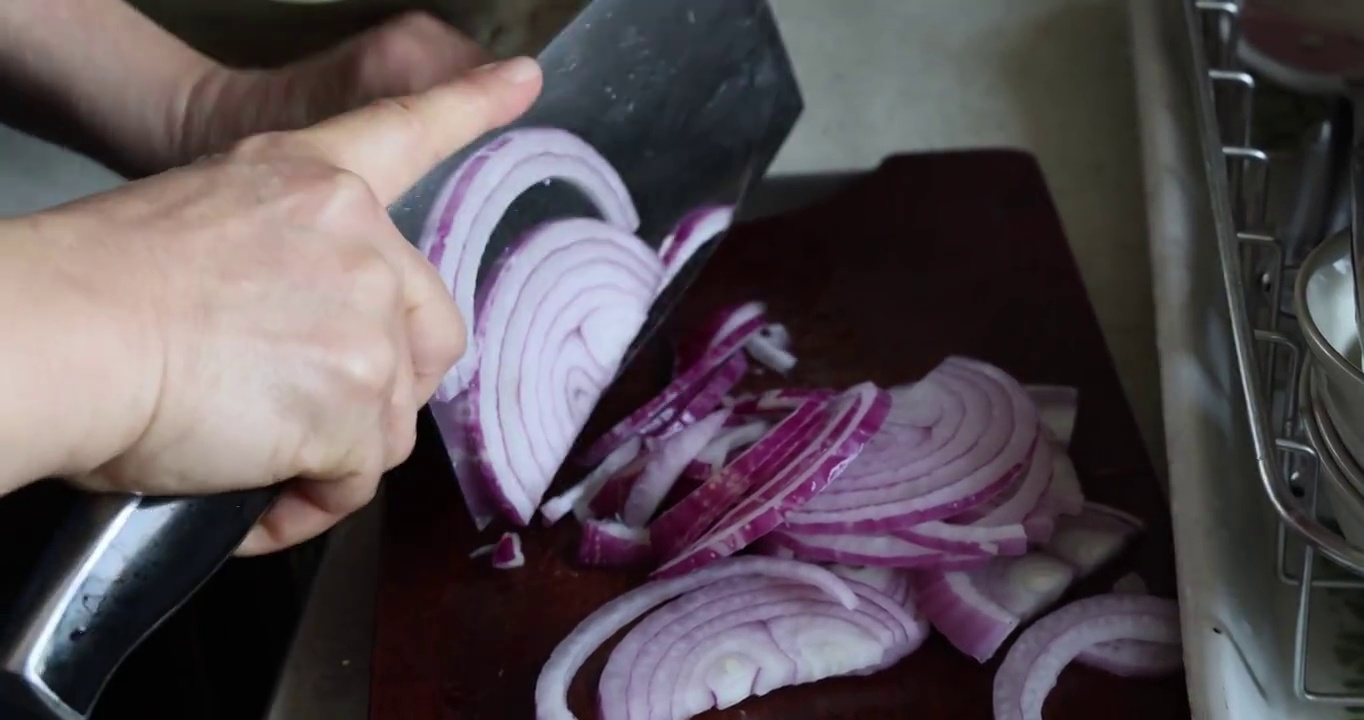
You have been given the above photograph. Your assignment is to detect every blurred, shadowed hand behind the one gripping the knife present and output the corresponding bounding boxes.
[165,12,492,170]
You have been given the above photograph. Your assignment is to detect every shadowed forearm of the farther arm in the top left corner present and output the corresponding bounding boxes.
[0,0,214,169]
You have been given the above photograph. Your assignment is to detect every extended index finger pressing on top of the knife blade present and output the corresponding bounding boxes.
[295,57,540,205]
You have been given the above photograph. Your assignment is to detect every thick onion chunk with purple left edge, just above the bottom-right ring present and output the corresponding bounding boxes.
[914,552,1075,663]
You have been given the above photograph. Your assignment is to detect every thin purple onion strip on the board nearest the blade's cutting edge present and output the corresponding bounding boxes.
[581,303,767,465]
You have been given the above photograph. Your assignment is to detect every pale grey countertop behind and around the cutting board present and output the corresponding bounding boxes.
[0,0,1163,720]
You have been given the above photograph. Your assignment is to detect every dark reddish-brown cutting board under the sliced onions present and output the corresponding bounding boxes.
[371,150,1189,720]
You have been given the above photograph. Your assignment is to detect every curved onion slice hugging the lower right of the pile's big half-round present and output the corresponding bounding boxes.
[896,428,1056,555]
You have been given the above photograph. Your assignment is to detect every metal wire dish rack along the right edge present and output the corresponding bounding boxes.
[1185,0,1364,706]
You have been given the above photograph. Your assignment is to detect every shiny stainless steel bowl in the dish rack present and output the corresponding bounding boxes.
[1293,232,1364,477]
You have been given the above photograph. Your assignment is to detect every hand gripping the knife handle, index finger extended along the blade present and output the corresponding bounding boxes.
[35,60,540,554]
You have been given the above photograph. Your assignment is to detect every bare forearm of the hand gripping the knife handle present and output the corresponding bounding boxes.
[0,214,154,494]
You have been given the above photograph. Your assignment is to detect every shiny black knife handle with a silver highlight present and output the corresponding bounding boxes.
[0,487,280,720]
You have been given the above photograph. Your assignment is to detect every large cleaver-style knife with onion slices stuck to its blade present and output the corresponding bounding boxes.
[0,0,802,720]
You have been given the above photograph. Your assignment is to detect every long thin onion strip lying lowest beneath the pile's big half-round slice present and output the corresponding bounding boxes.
[762,529,992,570]
